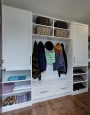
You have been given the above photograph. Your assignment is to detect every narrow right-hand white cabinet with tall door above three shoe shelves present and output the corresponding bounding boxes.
[72,22,88,95]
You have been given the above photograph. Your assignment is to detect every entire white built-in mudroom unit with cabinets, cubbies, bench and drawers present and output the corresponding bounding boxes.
[2,5,88,112]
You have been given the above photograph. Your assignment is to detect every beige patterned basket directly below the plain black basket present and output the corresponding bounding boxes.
[54,29,68,38]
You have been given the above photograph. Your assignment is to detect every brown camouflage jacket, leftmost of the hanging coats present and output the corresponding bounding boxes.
[32,41,41,80]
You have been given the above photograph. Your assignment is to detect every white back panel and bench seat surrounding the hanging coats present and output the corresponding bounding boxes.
[32,38,73,86]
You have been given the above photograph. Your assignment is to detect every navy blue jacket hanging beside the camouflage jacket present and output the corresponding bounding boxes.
[38,41,46,72]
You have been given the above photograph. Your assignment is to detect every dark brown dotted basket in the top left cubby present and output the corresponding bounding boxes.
[36,16,50,26]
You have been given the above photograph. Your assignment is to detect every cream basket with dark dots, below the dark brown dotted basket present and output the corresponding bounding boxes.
[35,26,51,36]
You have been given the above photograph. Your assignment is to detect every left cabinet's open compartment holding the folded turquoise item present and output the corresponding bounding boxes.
[2,70,31,83]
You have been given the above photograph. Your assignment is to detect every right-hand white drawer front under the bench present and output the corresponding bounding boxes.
[55,83,70,94]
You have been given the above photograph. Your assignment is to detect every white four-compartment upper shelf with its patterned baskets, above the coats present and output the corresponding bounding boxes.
[32,14,71,40]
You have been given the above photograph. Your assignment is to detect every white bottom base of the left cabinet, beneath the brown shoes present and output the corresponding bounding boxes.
[2,101,32,113]
